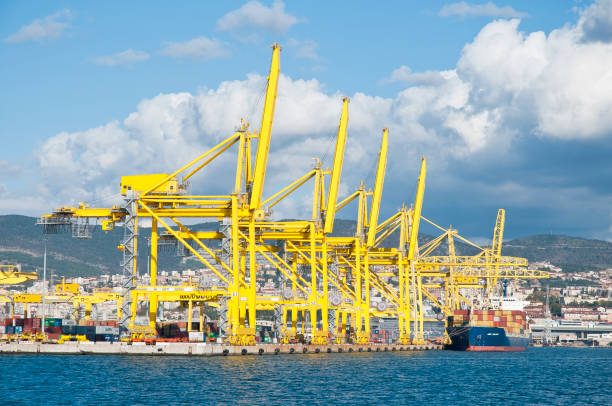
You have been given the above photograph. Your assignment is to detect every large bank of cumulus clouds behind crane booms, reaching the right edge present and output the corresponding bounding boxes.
[19,5,612,241]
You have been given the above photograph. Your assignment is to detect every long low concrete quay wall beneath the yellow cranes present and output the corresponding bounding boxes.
[0,342,443,356]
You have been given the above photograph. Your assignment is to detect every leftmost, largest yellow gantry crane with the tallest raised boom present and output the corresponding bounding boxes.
[40,44,280,344]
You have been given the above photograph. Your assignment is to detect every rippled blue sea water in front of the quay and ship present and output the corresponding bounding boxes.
[0,348,612,405]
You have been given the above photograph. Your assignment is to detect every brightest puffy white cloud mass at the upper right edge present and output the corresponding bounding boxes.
[457,20,612,139]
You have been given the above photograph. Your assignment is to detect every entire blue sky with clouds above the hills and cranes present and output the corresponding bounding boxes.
[0,0,612,244]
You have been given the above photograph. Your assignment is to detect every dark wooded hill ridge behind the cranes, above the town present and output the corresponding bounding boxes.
[0,215,612,276]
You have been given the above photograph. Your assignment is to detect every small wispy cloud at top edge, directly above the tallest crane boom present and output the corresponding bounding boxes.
[217,0,299,33]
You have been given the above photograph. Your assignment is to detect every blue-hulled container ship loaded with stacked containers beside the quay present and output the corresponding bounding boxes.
[447,310,531,351]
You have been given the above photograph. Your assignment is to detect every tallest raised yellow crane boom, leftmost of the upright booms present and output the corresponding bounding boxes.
[250,44,281,210]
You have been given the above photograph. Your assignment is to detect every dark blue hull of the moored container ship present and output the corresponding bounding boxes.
[447,326,531,351]
